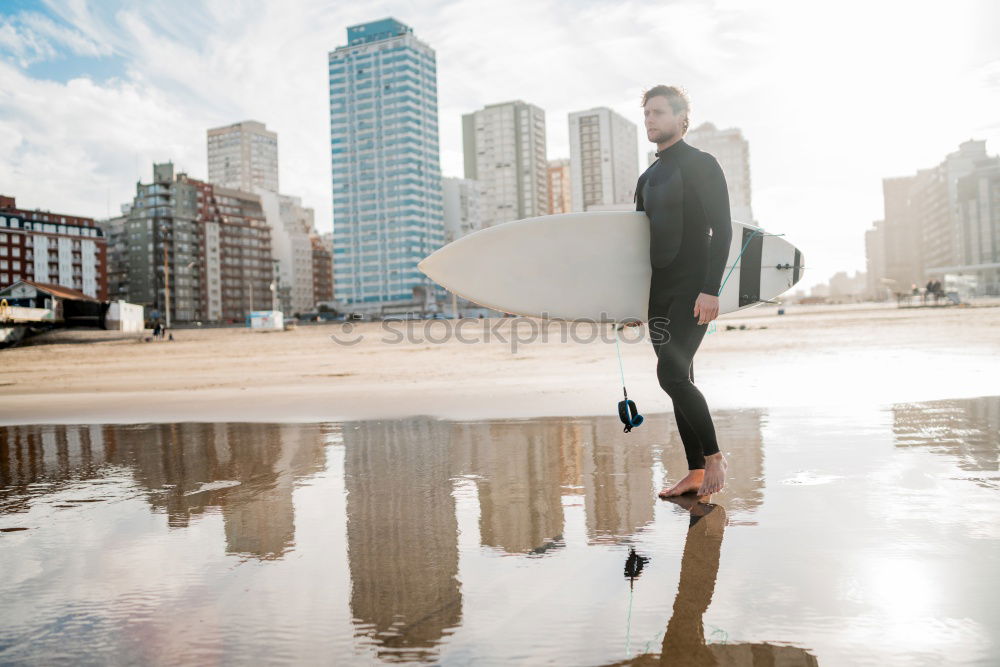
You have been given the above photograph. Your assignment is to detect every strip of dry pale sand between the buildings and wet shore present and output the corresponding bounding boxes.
[0,304,1000,424]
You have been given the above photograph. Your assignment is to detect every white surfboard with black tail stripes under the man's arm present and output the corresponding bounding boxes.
[417,211,803,322]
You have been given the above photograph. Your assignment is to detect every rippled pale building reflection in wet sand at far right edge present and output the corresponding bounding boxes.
[892,396,1000,487]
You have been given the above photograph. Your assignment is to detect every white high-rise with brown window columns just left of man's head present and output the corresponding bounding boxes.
[569,107,639,212]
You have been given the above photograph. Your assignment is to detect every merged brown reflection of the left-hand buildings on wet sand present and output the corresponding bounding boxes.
[0,424,325,559]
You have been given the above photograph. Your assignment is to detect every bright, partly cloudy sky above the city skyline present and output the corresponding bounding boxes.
[0,0,1000,287]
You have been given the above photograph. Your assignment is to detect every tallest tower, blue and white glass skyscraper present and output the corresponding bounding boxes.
[329,18,445,313]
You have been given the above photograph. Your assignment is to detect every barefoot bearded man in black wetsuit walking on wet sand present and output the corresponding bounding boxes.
[635,86,732,498]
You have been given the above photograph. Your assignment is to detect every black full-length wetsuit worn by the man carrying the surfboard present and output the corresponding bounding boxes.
[635,139,733,470]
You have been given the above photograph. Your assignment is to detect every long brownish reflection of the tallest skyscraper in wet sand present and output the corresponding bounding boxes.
[343,419,462,660]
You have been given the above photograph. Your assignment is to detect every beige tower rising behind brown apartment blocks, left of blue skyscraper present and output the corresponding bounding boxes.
[208,120,278,192]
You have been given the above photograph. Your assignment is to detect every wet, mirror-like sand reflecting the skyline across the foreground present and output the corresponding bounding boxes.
[0,397,1000,665]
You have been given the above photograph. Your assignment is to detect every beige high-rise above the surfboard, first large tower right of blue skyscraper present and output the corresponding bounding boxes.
[462,100,549,227]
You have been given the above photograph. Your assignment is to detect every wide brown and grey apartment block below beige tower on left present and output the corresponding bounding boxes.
[116,162,274,322]
